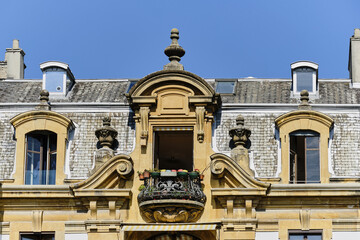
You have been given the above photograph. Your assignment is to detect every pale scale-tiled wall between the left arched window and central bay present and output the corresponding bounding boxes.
[64,112,135,178]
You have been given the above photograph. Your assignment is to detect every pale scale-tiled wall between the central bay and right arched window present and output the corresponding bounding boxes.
[215,112,278,177]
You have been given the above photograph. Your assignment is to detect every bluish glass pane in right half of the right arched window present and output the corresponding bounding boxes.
[306,150,320,182]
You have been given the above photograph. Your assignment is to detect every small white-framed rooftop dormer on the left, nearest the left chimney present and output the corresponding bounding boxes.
[40,61,75,97]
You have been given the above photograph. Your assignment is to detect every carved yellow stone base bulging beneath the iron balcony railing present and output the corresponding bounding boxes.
[140,200,204,223]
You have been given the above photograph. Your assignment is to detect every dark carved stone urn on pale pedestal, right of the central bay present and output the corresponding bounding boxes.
[229,115,254,176]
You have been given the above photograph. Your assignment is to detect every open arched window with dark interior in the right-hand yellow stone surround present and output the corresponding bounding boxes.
[290,131,320,183]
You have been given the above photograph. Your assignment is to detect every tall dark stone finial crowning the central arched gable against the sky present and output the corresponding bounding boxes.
[164,28,185,70]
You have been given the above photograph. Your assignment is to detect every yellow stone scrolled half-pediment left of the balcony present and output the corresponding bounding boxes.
[70,155,134,197]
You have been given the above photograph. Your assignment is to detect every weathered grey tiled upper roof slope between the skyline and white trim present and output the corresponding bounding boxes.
[0,79,360,104]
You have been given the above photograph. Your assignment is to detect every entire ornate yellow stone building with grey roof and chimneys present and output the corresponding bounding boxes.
[0,29,360,240]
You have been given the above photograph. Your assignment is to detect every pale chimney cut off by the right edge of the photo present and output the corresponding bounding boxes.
[349,28,360,88]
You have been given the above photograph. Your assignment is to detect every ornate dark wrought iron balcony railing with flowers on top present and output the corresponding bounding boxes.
[138,173,206,203]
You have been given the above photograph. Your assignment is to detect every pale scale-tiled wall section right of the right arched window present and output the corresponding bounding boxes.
[330,114,360,177]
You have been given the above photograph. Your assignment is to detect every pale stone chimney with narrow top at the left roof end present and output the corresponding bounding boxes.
[5,39,26,79]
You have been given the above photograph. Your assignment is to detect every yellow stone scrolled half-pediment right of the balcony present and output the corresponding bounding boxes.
[210,153,270,196]
